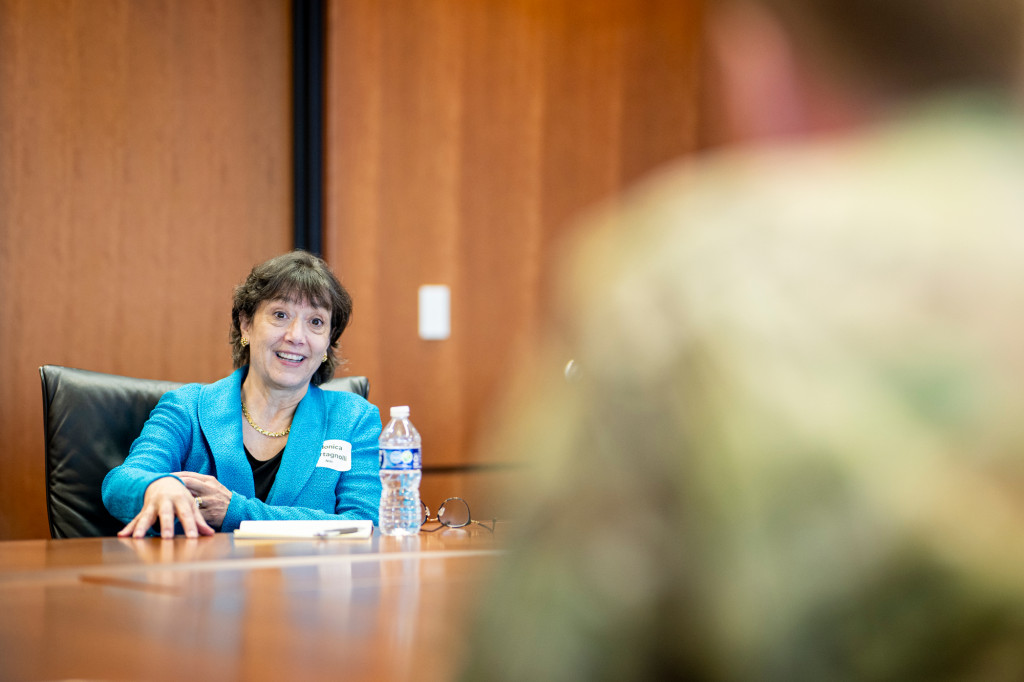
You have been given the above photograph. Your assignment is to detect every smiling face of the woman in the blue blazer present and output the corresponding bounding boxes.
[239,299,331,391]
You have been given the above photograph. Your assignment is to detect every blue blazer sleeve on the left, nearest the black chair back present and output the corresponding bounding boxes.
[101,385,198,523]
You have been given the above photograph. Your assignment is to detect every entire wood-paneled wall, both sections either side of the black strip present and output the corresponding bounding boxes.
[0,0,699,539]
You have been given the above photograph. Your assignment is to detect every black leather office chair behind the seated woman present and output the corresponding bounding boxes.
[39,365,370,538]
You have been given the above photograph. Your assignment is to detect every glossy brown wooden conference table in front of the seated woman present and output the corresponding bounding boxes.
[0,526,502,681]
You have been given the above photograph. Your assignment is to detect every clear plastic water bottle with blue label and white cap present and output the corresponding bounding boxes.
[380,406,423,536]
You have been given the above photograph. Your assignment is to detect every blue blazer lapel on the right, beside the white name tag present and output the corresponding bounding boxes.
[266,386,327,507]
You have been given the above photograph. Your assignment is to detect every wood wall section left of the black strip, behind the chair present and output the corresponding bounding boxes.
[0,0,292,539]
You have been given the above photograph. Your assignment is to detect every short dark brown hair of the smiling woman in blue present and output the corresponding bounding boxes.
[230,250,352,386]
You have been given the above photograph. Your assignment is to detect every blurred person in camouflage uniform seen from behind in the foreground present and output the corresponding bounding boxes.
[464,0,1024,680]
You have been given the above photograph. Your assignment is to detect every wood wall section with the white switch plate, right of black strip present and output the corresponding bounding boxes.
[325,0,699,516]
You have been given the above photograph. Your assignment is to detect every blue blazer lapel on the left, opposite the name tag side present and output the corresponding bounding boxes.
[199,367,256,498]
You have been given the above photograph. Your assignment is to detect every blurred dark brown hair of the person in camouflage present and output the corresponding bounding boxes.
[757,0,1024,93]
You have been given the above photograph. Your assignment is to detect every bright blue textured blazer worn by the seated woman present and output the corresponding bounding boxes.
[102,367,381,531]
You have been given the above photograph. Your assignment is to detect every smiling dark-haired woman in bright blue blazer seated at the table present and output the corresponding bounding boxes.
[102,251,381,538]
